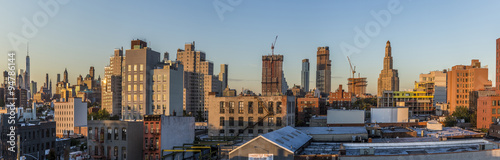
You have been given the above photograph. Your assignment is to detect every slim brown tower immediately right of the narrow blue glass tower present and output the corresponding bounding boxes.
[316,46,332,95]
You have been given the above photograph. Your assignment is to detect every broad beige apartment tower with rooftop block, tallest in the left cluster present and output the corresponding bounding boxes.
[122,40,160,120]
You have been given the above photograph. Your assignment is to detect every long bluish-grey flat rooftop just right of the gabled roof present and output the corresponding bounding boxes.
[295,126,368,135]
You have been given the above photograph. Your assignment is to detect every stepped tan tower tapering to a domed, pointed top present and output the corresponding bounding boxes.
[377,41,399,97]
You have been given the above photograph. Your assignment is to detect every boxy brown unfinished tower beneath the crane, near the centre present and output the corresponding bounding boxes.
[262,55,286,96]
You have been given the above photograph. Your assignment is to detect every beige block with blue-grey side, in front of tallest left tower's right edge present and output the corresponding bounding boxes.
[152,61,184,116]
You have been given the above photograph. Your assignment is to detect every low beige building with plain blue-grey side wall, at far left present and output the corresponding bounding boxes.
[54,98,87,137]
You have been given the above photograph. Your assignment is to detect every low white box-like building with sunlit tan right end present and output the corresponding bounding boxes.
[371,107,409,123]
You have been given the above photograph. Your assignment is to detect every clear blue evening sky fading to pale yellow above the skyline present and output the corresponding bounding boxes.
[0,0,500,94]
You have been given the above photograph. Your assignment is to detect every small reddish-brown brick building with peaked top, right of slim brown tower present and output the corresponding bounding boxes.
[328,85,354,109]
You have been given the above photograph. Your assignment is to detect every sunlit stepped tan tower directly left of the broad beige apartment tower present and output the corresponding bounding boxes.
[101,49,124,117]
